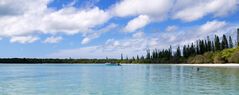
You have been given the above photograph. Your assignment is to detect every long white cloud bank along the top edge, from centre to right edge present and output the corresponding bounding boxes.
[111,0,238,22]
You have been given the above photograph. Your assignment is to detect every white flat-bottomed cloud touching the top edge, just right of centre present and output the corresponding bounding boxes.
[112,0,173,18]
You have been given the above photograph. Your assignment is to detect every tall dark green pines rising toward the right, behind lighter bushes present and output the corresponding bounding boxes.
[127,29,239,63]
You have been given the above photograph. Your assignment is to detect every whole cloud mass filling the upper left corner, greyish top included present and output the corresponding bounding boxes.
[0,0,111,43]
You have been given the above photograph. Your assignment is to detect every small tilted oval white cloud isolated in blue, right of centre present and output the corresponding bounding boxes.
[124,15,150,32]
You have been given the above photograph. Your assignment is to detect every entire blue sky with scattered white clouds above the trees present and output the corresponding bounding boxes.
[0,0,239,58]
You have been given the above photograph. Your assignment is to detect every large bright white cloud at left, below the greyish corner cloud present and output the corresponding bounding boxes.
[0,7,109,36]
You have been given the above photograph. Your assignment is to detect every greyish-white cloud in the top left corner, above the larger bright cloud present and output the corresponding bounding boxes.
[0,0,51,17]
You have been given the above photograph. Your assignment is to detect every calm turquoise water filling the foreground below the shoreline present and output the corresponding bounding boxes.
[0,64,239,95]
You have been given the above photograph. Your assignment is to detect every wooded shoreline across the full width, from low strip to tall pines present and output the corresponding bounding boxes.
[0,29,239,64]
